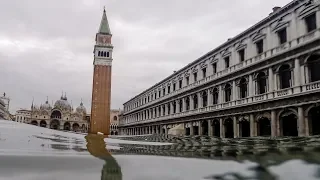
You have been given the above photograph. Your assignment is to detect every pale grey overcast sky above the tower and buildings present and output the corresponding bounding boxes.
[0,0,290,113]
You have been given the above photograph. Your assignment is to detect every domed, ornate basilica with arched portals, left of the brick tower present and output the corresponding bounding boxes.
[16,95,90,132]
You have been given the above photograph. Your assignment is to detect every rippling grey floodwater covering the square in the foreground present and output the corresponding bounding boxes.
[0,120,320,180]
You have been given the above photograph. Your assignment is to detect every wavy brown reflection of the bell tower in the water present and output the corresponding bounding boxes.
[85,134,122,180]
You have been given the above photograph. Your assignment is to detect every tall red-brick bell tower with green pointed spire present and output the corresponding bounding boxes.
[89,9,113,135]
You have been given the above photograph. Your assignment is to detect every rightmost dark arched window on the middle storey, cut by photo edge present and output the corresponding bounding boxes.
[307,54,320,82]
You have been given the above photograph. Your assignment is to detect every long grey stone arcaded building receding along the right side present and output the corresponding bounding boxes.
[119,0,320,138]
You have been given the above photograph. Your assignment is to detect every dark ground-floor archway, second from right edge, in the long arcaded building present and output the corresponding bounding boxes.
[278,108,298,136]
